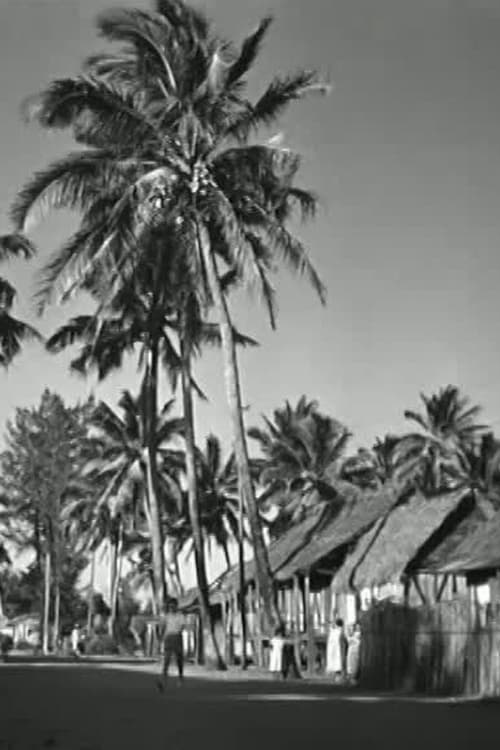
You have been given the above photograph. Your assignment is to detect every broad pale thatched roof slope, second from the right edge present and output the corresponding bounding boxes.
[333,490,469,592]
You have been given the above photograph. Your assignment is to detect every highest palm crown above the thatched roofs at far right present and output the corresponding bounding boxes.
[399,385,486,494]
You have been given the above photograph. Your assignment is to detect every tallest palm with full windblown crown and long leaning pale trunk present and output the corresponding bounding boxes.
[13,0,325,620]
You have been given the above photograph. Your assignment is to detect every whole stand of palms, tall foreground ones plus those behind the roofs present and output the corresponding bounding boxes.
[0,0,498,668]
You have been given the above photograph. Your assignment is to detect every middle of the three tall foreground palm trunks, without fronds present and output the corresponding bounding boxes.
[180,338,226,670]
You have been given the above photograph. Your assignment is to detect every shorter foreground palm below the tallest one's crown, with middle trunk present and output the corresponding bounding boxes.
[47,247,250,666]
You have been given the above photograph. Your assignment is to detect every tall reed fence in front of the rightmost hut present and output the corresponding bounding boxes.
[360,600,500,696]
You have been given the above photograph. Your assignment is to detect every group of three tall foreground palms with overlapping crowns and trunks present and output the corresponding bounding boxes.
[0,0,326,656]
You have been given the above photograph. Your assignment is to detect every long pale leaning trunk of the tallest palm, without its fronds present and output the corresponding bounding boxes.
[198,226,280,630]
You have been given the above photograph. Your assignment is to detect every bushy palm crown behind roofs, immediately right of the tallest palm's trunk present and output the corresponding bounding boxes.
[248,396,350,534]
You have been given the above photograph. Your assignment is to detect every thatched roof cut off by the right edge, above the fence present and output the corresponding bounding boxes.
[424,511,500,573]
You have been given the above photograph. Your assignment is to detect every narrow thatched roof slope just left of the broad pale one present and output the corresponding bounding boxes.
[276,487,399,581]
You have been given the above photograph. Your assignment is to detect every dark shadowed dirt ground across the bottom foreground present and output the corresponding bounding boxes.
[0,665,500,750]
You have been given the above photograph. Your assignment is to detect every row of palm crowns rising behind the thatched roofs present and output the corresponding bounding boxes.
[249,385,500,535]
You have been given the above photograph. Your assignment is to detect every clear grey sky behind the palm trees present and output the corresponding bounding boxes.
[0,0,500,458]
